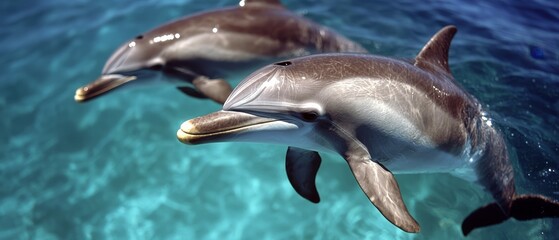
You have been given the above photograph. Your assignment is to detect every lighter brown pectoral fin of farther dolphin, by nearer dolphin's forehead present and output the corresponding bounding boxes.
[192,76,233,104]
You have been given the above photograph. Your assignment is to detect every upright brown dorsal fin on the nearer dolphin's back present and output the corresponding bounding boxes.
[414,25,457,75]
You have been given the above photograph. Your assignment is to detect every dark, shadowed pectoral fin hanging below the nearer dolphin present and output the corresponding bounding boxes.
[285,147,322,203]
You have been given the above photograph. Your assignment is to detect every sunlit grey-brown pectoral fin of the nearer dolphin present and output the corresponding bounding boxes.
[346,154,419,233]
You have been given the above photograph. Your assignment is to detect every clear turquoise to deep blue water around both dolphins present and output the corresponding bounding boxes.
[0,0,559,239]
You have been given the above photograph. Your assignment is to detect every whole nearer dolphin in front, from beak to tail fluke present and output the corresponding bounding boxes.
[177,26,559,235]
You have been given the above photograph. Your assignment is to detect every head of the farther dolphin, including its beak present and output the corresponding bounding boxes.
[74,32,180,102]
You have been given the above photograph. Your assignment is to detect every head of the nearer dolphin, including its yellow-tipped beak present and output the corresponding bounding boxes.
[177,56,350,152]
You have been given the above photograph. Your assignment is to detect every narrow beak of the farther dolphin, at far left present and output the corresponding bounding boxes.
[74,74,136,102]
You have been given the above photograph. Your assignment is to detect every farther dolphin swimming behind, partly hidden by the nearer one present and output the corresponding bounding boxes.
[74,0,367,104]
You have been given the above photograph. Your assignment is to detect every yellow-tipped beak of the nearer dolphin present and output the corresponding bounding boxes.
[177,111,298,144]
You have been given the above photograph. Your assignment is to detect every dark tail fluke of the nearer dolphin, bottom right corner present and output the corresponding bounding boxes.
[462,195,559,236]
